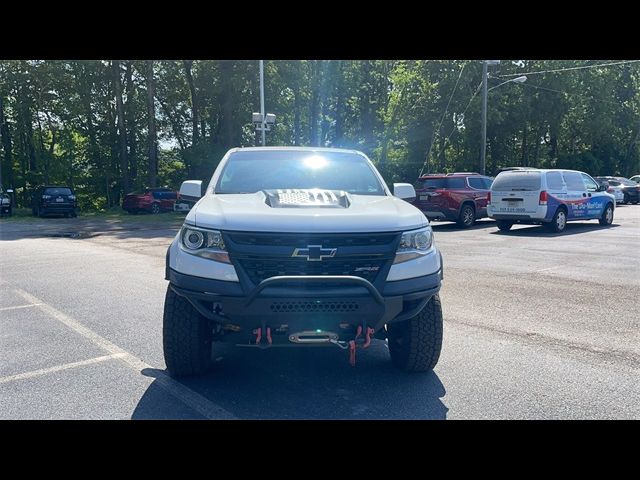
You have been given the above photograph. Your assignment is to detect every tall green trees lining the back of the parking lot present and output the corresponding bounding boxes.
[0,60,640,210]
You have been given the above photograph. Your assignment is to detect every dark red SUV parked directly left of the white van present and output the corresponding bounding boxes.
[413,172,492,228]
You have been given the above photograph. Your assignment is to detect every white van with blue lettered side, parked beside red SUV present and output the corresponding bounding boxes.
[487,168,616,232]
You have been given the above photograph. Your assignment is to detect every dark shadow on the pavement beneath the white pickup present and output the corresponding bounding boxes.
[132,341,448,419]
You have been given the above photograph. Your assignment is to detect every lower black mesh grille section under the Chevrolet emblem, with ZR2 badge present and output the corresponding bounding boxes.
[237,259,387,285]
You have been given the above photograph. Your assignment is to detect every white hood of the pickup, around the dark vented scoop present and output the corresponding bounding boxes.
[186,192,429,233]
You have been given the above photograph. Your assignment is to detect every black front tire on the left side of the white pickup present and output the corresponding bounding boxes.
[162,287,212,377]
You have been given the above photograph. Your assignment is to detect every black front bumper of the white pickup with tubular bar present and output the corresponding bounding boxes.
[167,264,443,343]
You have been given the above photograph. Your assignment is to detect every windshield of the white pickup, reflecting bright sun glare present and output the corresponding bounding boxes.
[214,150,385,195]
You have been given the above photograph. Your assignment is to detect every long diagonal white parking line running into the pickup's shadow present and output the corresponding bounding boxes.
[15,288,237,420]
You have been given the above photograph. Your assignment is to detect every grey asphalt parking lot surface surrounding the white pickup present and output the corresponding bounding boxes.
[0,205,640,419]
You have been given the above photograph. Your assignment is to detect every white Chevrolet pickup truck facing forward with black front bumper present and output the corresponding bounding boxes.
[163,147,443,376]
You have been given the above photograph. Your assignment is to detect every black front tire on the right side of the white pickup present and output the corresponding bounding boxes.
[387,294,442,372]
